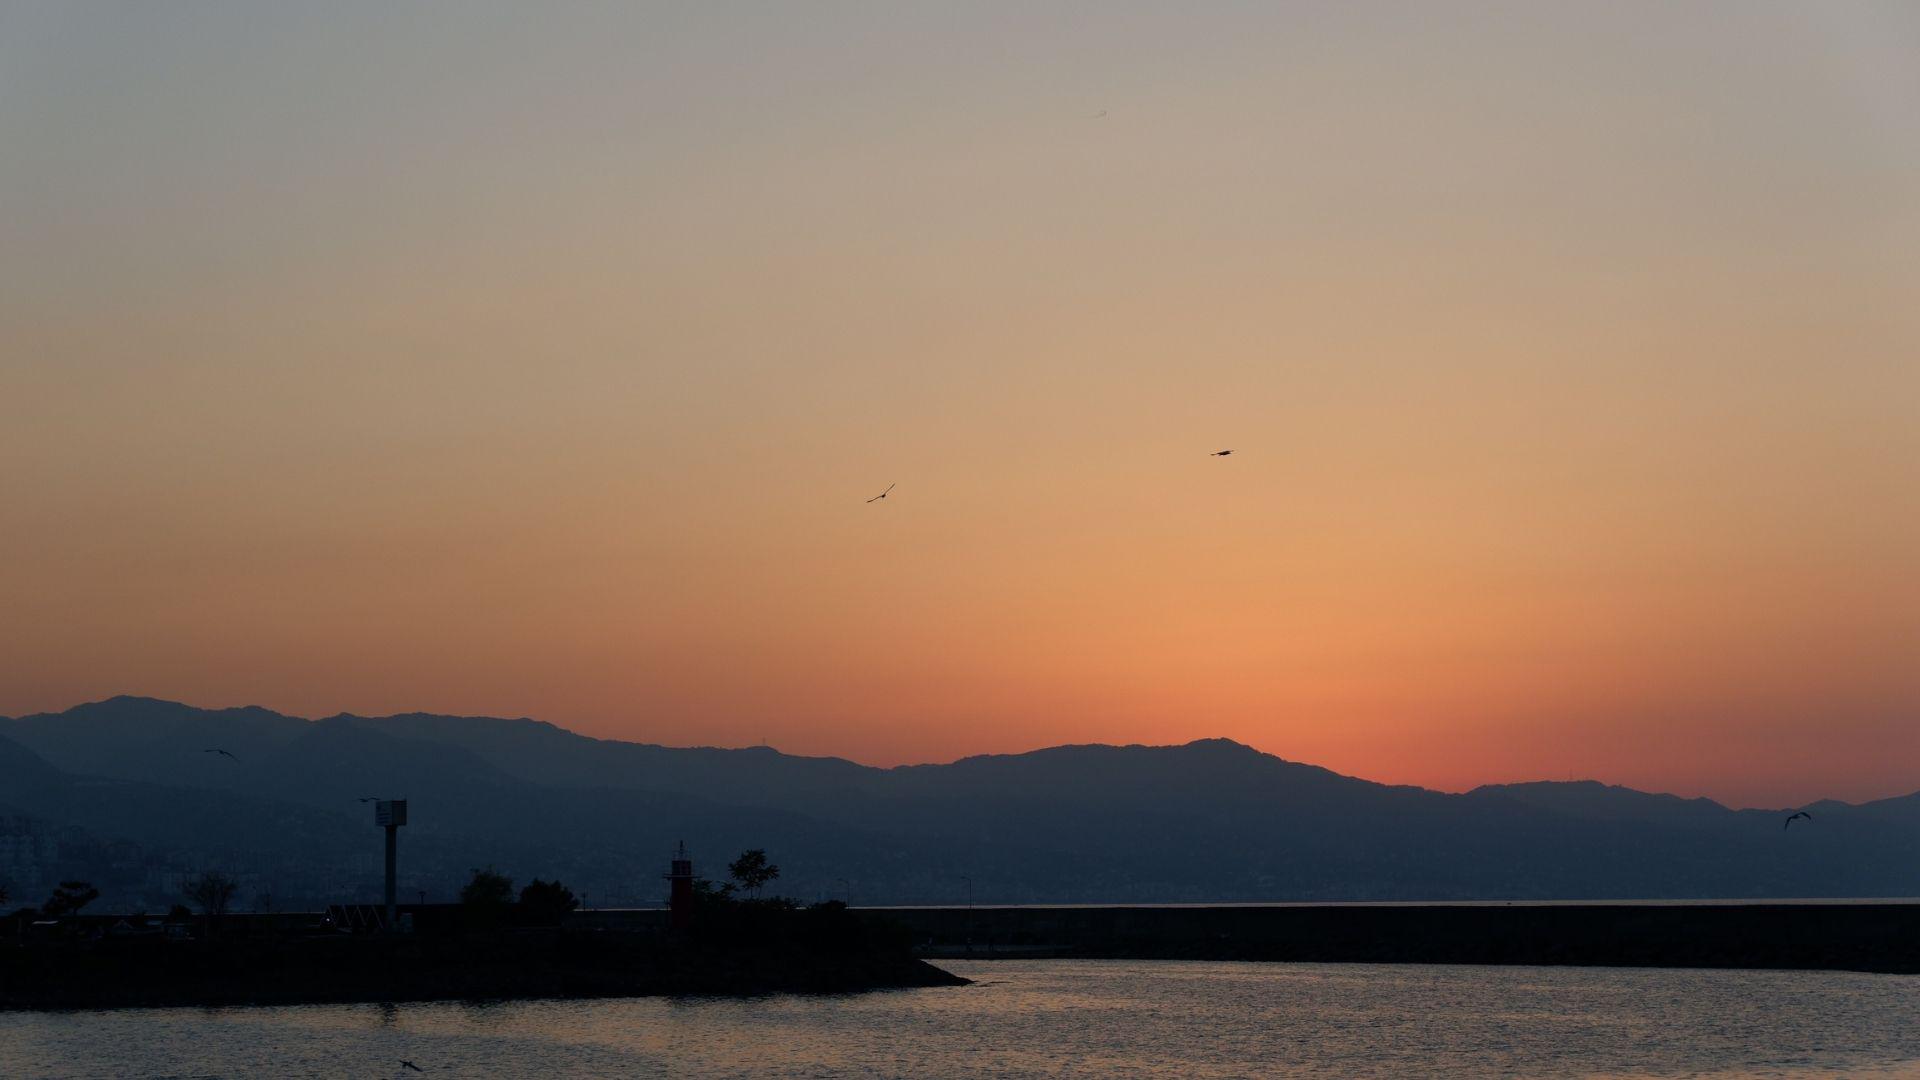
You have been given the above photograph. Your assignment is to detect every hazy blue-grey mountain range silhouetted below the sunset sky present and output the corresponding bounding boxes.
[0,698,1920,903]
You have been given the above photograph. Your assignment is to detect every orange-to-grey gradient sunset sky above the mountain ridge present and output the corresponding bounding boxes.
[0,0,1920,805]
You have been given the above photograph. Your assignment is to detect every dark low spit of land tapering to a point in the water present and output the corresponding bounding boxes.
[0,907,966,1009]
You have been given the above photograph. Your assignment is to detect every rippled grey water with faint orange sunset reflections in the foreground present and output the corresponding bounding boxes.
[0,961,1920,1078]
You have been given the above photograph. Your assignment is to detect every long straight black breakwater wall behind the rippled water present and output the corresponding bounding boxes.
[885,903,1920,972]
